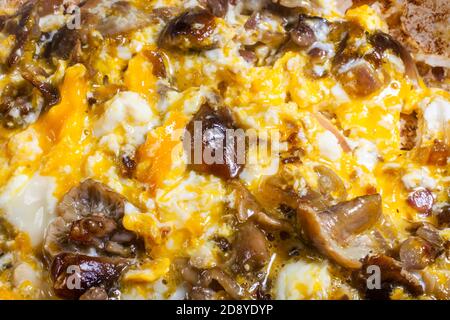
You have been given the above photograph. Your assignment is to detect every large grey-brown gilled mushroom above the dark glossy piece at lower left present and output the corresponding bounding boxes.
[44,180,140,259]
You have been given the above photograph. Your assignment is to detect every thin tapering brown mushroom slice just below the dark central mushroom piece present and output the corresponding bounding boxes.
[230,180,292,232]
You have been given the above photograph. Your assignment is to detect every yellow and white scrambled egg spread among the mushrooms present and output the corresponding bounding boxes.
[0,0,450,299]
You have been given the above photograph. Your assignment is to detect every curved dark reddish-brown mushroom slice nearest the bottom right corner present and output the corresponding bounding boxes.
[362,255,423,295]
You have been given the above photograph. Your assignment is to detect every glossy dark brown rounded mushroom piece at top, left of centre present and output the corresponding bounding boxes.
[158,8,217,51]
